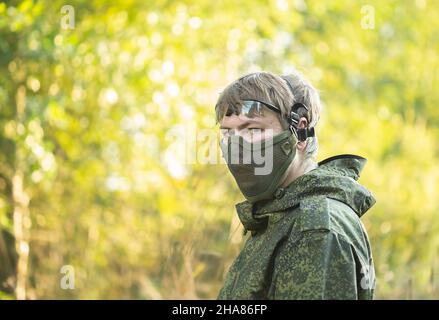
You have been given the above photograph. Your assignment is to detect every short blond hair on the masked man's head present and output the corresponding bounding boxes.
[215,70,321,158]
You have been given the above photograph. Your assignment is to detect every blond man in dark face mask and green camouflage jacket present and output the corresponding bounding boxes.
[215,72,375,299]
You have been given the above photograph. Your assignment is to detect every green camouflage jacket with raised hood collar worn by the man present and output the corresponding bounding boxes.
[218,155,375,299]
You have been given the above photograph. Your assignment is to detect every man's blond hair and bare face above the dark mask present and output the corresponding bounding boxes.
[215,71,321,160]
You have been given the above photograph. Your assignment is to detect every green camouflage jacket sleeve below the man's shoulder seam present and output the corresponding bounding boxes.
[272,230,359,299]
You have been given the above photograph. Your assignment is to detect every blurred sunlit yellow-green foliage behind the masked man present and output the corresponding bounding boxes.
[0,0,439,299]
